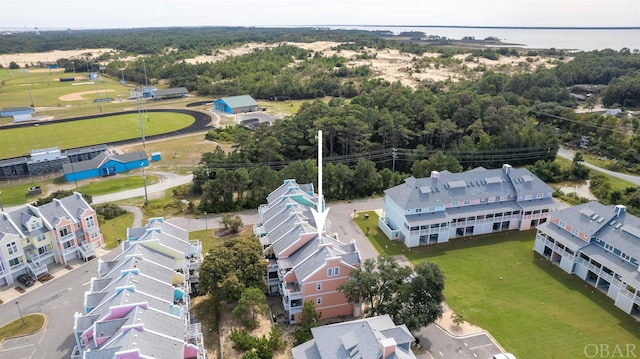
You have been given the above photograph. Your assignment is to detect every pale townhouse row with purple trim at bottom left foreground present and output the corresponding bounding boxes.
[71,218,207,359]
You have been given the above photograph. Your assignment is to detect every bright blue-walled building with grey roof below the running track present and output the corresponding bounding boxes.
[62,151,149,182]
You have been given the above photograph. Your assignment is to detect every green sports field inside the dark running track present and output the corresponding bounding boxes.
[0,112,195,158]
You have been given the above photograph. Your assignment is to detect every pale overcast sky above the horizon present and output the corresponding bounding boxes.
[0,0,640,30]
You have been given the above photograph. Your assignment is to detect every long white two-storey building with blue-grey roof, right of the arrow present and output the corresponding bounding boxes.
[378,164,557,247]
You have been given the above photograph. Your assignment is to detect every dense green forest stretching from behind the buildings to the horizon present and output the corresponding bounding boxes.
[0,27,640,213]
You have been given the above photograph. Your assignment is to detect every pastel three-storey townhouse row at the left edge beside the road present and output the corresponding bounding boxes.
[0,192,104,286]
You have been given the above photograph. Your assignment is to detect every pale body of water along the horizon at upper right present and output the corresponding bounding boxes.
[328,25,640,51]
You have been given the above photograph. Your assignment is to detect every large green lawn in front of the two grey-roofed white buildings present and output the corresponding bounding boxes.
[356,212,640,359]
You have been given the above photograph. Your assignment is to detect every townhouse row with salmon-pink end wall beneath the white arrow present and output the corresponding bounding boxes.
[254,179,361,323]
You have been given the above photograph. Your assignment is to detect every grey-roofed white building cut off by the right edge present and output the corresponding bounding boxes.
[534,202,640,319]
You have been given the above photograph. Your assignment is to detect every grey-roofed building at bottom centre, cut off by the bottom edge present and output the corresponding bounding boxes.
[291,314,416,359]
